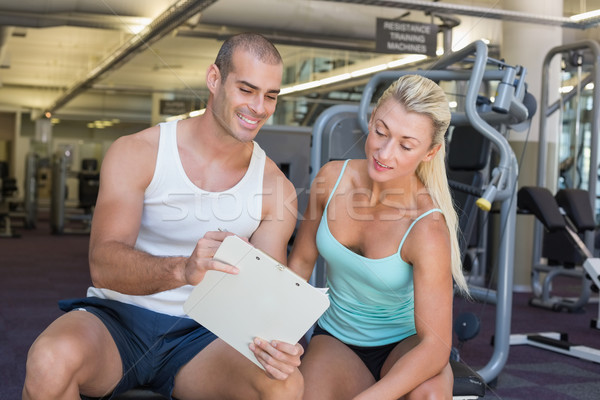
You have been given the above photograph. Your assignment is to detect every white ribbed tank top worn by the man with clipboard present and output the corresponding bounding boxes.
[87,121,266,316]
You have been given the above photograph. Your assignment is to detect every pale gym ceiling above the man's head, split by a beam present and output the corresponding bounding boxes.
[0,0,600,128]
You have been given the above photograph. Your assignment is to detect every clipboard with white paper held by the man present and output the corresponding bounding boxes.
[183,236,329,369]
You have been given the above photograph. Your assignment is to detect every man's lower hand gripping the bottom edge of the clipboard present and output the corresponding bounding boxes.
[249,338,304,380]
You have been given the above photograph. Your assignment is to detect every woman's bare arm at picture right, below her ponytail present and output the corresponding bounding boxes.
[355,213,453,400]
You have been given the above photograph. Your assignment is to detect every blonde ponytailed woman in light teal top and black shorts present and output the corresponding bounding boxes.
[288,75,466,400]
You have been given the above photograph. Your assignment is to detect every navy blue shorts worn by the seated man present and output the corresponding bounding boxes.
[59,297,217,398]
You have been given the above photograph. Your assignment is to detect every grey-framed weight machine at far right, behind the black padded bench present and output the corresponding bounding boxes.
[530,40,600,312]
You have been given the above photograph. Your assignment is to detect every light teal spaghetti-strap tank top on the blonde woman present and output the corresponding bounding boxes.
[316,160,442,347]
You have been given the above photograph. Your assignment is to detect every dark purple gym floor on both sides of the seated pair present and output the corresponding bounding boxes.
[0,211,600,400]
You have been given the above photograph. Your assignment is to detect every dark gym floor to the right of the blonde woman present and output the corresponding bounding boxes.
[454,278,600,400]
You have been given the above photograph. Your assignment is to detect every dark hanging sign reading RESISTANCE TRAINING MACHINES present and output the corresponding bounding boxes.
[375,18,437,57]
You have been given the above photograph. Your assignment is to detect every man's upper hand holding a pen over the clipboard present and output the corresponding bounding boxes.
[183,231,239,285]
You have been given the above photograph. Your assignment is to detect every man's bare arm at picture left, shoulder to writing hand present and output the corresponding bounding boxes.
[89,127,237,295]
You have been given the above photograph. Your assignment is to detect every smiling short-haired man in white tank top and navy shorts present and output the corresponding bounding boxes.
[23,34,303,400]
